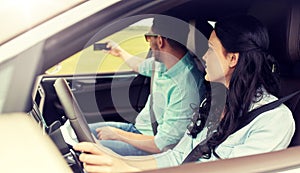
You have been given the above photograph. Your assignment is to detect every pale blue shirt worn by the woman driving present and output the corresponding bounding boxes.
[153,92,295,168]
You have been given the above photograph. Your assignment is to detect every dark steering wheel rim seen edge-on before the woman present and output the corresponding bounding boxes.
[54,78,95,143]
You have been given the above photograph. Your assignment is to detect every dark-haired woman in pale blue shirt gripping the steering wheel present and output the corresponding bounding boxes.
[74,16,295,172]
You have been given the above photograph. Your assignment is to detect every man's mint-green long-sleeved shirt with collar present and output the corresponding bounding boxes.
[135,53,205,150]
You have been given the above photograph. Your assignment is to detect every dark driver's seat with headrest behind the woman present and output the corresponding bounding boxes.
[249,0,300,146]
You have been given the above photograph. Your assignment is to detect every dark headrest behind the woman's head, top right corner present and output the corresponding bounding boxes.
[248,0,300,73]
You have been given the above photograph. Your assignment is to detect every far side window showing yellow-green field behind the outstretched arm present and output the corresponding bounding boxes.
[46,18,152,75]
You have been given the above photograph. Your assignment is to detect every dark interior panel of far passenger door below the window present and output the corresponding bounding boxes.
[41,72,150,124]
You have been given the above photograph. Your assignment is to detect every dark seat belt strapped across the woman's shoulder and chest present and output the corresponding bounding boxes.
[182,90,300,163]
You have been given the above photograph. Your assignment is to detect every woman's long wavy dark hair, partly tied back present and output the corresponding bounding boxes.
[207,15,279,159]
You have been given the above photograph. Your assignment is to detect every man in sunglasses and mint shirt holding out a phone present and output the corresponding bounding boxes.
[90,16,205,155]
